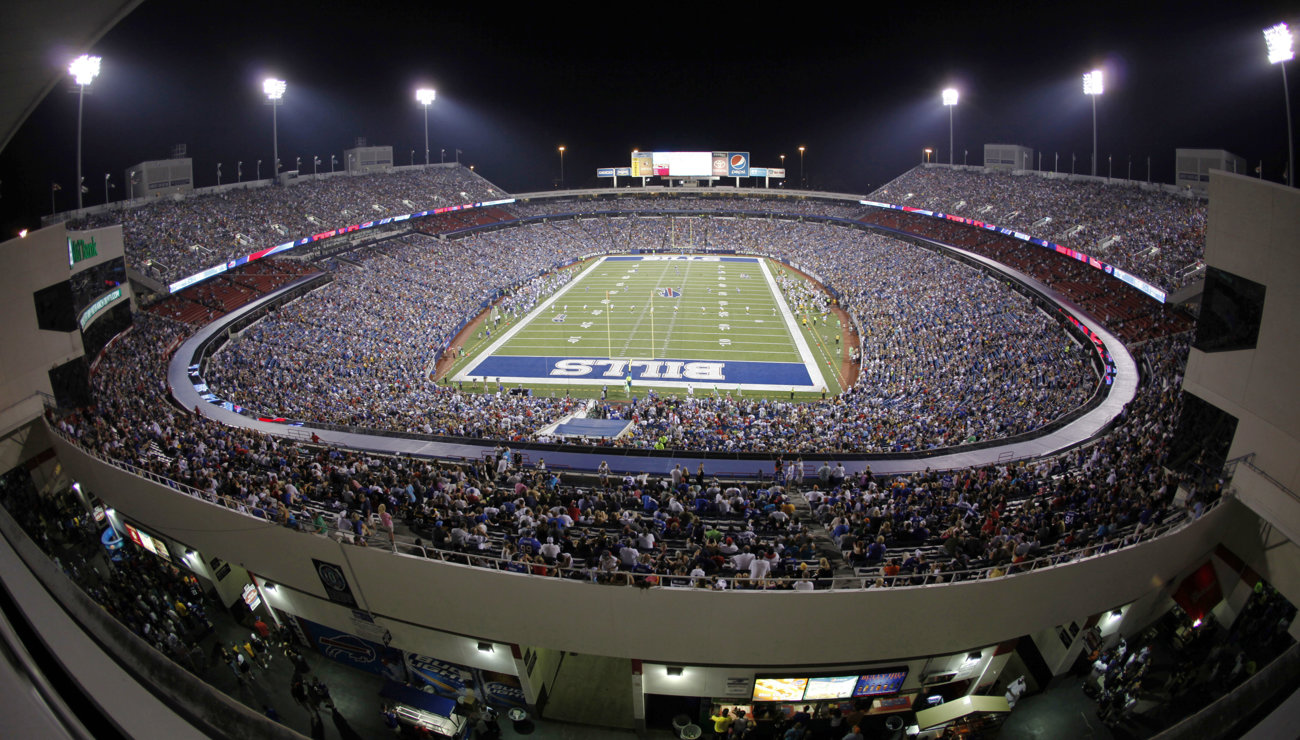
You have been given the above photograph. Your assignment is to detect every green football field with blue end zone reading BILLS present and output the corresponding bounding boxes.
[452,255,826,393]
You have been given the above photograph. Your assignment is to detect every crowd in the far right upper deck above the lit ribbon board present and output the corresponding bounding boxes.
[871,168,1206,291]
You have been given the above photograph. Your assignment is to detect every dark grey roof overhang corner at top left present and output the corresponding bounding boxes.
[0,0,142,150]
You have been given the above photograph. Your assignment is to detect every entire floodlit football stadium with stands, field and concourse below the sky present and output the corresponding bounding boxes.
[0,1,1300,739]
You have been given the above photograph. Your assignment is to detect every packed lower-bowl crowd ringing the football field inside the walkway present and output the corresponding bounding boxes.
[205,218,1097,451]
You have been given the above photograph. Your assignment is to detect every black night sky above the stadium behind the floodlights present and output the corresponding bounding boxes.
[0,0,1300,237]
